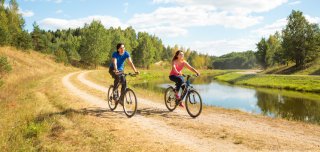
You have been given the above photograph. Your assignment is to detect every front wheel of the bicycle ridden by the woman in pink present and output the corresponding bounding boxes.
[186,90,202,118]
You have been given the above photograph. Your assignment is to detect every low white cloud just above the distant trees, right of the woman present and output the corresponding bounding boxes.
[191,38,256,56]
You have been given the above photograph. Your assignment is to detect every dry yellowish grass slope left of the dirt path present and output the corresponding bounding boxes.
[0,47,119,151]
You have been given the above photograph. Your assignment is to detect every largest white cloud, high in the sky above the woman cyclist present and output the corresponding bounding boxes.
[127,5,263,36]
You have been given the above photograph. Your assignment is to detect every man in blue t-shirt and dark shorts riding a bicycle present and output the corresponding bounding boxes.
[109,43,139,101]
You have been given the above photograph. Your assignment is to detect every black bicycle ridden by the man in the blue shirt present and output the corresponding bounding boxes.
[107,73,138,118]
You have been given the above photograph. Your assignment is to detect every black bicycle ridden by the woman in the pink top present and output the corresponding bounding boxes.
[164,75,202,118]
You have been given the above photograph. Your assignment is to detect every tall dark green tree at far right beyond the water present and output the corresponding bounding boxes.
[282,10,319,67]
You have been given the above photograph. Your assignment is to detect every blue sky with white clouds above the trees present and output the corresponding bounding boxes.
[14,0,320,56]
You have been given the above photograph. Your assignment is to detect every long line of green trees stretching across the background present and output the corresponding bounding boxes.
[0,0,320,69]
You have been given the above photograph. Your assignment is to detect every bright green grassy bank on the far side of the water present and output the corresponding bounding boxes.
[215,73,320,93]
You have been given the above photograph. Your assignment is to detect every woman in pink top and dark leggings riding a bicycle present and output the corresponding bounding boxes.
[169,50,200,107]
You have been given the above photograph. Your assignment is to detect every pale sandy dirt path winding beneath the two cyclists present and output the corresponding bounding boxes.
[63,71,320,151]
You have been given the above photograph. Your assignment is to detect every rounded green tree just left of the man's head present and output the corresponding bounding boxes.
[79,21,111,67]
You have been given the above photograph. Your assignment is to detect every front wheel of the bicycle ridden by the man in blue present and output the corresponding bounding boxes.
[123,88,138,118]
